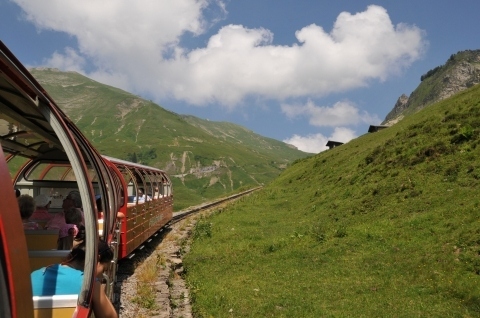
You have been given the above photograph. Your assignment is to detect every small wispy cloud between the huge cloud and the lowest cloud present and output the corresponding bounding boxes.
[281,100,380,127]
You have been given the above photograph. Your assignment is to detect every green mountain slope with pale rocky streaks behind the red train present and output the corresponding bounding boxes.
[30,68,308,209]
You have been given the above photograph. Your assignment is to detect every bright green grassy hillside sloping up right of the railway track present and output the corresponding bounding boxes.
[184,85,480,317]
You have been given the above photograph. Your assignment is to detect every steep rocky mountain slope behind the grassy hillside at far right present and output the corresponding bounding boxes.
[382,50,480,125]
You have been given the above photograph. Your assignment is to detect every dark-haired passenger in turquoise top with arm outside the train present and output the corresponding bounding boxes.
[31,241,118,318]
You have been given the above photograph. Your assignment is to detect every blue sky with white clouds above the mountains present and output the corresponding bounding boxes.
[0,0,480,152]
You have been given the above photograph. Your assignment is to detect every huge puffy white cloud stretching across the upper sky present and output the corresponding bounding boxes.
[14,0,425,108]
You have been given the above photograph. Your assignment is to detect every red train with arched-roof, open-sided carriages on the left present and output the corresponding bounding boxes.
[0,42,173,317]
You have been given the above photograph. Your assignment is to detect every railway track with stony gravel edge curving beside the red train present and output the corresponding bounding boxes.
[114,187,261,318]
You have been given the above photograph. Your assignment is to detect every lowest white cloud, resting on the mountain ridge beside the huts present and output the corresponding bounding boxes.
[283,127,357,153]
